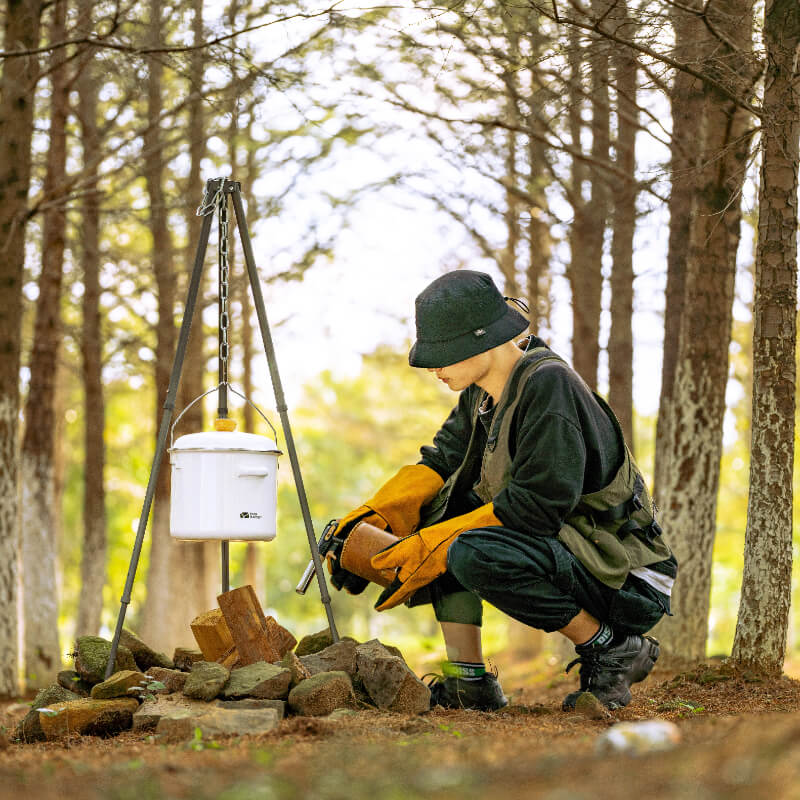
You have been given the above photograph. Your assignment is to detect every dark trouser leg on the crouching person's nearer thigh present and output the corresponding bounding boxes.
[447,527,668,633]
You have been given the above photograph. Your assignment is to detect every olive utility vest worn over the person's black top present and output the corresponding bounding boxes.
[420,347,671,589]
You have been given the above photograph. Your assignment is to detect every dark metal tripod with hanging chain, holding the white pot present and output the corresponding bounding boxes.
[105,178,339,678]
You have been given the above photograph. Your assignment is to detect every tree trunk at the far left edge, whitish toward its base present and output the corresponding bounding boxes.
[0,0,43,696]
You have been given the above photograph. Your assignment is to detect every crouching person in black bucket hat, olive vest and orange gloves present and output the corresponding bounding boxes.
[318,270,677,710]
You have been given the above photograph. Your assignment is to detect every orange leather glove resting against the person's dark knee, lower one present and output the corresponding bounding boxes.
[371,503,503,611]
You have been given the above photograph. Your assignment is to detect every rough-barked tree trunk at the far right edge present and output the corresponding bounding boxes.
[733,0,800,674]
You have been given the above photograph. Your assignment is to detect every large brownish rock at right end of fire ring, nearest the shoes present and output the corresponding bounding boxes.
[356,639,431,714]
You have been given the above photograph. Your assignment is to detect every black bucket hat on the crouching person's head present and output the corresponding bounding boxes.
[408,269,529,369]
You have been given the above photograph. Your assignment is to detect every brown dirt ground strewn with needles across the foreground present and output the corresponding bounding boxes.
[0,664,800,800]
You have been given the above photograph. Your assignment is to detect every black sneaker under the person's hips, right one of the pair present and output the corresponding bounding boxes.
[561,634,659,711]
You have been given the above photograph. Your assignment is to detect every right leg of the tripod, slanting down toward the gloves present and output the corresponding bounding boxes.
[231,184,339,642]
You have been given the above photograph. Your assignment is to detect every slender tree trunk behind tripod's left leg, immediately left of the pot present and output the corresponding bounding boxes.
[141,0,180,650]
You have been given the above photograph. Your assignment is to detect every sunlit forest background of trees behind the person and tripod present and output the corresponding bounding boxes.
[0,0,800,694]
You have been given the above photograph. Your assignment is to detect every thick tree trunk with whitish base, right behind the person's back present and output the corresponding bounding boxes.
[658,2,752,662]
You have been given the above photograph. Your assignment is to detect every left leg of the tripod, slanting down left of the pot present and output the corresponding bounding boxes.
[105,205,213,678]
